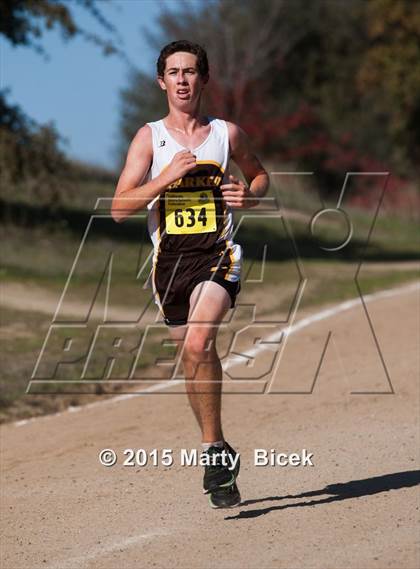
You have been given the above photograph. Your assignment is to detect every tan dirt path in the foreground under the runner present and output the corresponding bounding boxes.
[1,282,420,569]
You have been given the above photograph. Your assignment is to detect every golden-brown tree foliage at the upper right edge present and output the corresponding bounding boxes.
[357,0,420,169]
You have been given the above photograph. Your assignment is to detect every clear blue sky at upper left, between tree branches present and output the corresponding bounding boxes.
[0,0,174,168]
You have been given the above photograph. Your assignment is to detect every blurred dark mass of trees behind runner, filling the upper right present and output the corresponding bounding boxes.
[118,0,420,209]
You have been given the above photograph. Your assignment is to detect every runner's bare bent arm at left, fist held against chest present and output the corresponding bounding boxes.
[111,125,196,223]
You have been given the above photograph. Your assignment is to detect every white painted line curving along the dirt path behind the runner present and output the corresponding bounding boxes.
[12,282,420,427]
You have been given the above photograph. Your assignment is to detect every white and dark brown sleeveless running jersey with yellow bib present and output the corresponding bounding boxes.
[147,118,241,268]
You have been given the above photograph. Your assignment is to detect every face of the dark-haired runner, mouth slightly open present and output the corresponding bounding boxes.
[158,51,206,107]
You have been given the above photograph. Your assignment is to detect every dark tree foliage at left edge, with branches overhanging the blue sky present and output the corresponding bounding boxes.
[0,0,123,210]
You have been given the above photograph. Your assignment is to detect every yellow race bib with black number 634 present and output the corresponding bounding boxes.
[165,190,217,234]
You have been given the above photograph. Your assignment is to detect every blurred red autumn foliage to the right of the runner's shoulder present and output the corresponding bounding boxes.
[208,80,420,210]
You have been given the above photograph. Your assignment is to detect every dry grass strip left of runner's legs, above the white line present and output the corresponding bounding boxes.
[0,307,175,422]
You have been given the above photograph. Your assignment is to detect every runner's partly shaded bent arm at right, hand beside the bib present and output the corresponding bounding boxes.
[220,122,270,208]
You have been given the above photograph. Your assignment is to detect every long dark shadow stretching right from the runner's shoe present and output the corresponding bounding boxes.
[225,470,420,520]
